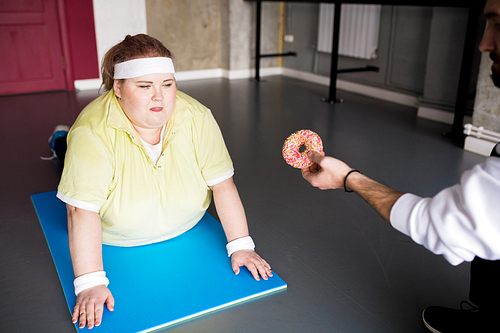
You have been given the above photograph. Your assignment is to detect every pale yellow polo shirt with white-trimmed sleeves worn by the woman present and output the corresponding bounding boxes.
[57,90,233,246]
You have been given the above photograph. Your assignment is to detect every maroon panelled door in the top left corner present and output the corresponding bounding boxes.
[0,0,66,95]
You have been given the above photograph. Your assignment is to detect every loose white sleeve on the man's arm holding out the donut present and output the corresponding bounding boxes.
[390,157,500,265]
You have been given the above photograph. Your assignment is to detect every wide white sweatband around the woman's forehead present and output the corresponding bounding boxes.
[114,57,175,79]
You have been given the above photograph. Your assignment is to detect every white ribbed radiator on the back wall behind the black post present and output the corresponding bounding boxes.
[317,3,382,59]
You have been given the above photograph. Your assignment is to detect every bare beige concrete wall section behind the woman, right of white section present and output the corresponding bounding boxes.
[146,0,279,72]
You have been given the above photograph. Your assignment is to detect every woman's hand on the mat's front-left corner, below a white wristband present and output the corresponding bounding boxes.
[73,285,115,329]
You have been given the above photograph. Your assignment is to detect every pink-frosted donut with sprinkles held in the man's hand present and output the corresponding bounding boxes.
[283,130,323,169]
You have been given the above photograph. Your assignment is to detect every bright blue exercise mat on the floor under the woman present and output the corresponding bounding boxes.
[31,191,287,333]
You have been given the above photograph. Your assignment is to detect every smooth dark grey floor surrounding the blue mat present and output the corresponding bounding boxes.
[0,77,484,333]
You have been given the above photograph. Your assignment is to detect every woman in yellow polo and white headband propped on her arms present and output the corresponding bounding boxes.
[57,34,272,328]
